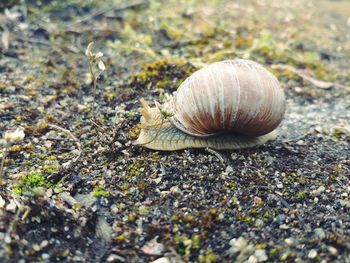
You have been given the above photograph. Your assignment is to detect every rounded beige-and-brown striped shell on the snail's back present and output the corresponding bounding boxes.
[171,59,285,137]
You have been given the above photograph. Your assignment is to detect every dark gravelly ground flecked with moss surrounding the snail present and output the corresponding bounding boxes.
[0,0,350,263]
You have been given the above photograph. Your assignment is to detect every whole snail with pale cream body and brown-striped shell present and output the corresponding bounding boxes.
[135,59,285,151]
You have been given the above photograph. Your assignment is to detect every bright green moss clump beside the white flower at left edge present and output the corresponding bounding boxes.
[12,172,47,195]
